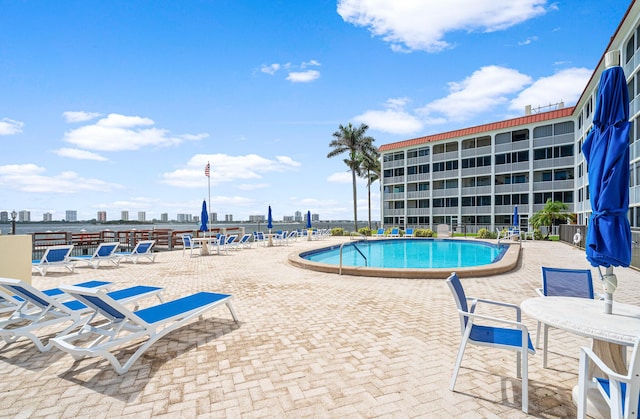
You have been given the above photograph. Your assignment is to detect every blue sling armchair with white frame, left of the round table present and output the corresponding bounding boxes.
[447,272,535,413]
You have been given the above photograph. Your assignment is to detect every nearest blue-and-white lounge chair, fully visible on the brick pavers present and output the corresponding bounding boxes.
[52,286,238,374]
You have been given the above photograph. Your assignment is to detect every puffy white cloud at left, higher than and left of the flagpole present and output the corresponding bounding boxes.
[64,114,208,151]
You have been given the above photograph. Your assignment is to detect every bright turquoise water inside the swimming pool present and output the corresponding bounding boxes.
[300,239,508,269]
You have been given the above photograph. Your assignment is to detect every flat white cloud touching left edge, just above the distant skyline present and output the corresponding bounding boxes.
[0,164,122,194]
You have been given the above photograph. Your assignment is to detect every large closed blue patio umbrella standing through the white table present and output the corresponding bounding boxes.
[582,60,631,313]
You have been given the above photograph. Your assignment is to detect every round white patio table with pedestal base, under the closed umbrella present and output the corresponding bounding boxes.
[520,297,640,417]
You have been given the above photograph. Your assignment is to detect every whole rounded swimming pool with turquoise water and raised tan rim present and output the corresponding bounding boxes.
[289,238,520,278]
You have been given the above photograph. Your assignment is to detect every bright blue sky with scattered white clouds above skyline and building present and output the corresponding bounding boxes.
[0,0,629,221]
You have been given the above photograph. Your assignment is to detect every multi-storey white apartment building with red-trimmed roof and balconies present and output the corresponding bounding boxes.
[380,1,640,231]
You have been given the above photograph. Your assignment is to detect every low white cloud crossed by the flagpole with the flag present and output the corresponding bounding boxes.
[161,154,300,188]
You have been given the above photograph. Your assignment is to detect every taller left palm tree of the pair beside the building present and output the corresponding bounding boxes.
[327,123,375,231]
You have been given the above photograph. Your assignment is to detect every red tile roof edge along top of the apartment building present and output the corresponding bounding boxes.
[378,106,574,151]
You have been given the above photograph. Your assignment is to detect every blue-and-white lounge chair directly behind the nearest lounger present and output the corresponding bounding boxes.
[0,278,162,352]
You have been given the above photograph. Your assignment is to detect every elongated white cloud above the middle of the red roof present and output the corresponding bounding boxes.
[418,66,531,121]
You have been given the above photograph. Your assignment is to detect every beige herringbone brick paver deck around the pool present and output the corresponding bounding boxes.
[0,238,640,419]
